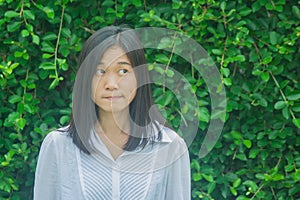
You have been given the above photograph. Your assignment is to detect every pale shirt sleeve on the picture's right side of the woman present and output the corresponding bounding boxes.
[165,141,191,200]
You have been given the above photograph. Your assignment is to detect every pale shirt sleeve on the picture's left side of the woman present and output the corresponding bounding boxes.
[34,132,60,200]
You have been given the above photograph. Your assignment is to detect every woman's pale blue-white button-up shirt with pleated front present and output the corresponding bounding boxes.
[34,124,191,200]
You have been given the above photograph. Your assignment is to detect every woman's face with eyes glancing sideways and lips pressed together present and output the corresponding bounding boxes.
[91,46,137,113]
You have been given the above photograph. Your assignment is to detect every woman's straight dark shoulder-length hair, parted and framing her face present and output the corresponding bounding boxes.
[68,26,164,154]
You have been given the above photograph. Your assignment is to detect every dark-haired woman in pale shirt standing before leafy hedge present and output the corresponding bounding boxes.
[34,26,190,200]
